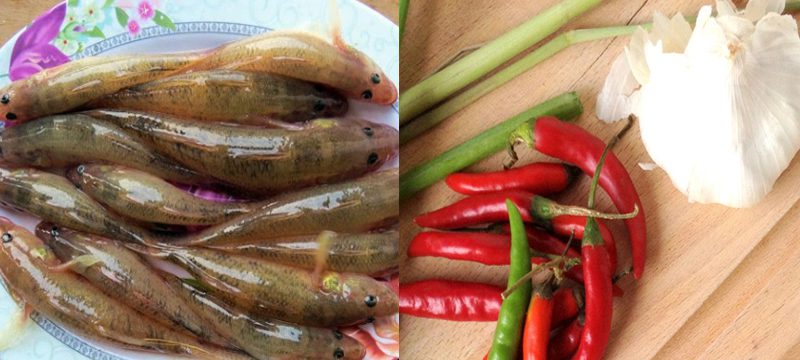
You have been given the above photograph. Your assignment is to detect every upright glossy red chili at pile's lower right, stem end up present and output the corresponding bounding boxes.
[573,218,613,360]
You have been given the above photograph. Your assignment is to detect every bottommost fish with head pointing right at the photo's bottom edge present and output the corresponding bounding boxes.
[166,275,366,360]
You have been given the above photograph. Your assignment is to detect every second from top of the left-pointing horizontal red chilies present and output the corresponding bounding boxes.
[414,190,534,229]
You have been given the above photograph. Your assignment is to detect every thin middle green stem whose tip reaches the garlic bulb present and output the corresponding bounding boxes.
[400,23,640,144]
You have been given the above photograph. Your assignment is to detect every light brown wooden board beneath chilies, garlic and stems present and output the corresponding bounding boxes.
[401,0,800,360]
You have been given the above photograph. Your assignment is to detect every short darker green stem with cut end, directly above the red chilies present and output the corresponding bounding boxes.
[400,92,583,200]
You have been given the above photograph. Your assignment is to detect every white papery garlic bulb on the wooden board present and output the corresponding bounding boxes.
[597,0,800,207]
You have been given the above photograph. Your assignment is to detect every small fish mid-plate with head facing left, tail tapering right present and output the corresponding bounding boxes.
[67,164,263,225]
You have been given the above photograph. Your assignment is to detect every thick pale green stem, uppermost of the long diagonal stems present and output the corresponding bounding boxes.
[400,0,602,125]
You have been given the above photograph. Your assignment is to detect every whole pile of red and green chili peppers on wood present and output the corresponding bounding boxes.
[400,117,646,359]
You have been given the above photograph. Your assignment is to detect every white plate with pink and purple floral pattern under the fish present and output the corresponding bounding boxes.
[0,0,399,360]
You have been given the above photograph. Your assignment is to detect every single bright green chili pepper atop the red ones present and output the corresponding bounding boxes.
[489,200,531,360]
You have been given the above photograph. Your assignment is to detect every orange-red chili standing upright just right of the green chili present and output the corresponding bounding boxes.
[522,281,553,360]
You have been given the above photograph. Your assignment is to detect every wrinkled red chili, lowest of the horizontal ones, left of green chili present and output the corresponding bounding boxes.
[400,280,504,321]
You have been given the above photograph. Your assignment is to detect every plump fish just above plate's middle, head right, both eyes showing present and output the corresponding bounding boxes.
[86,110,399,194]
